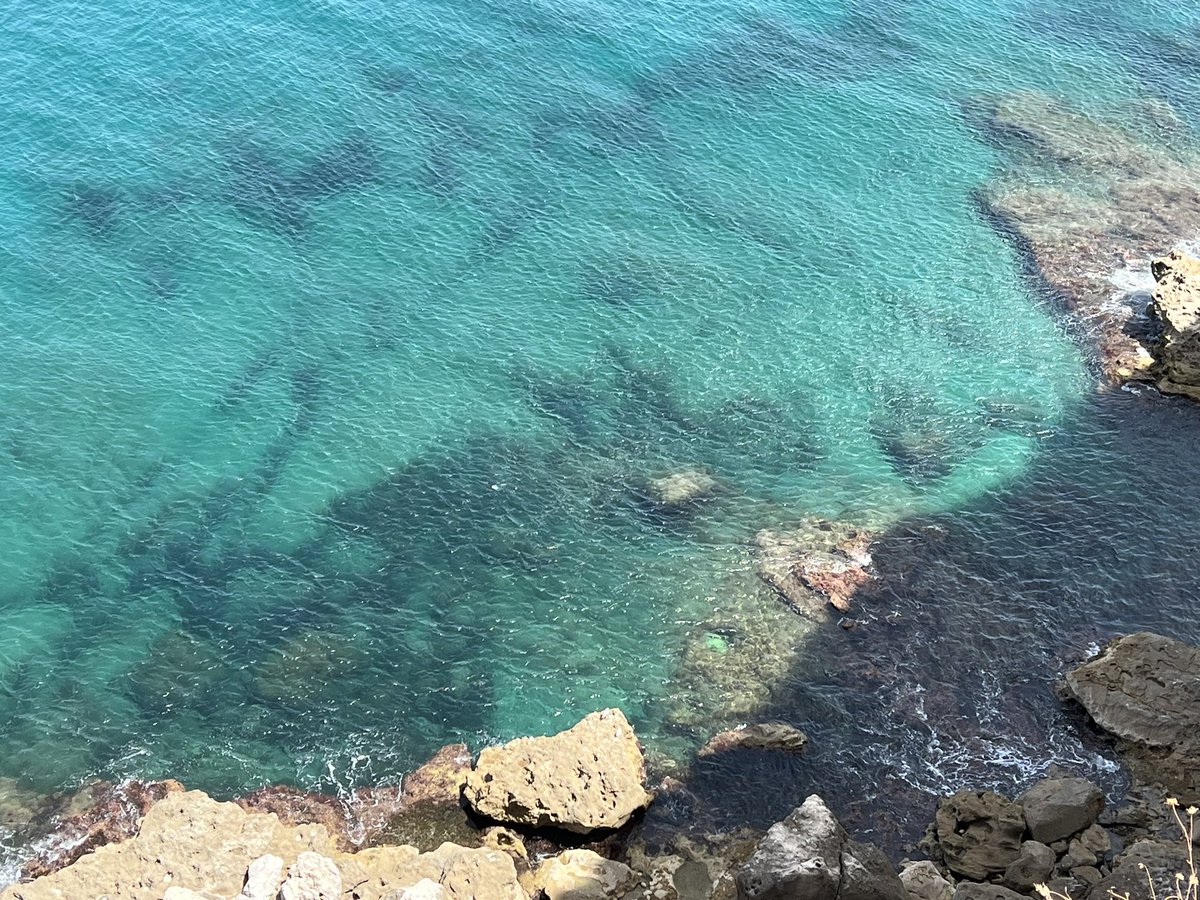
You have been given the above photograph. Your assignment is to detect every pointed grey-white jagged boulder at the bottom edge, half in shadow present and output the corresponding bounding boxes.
[737,794,907,900]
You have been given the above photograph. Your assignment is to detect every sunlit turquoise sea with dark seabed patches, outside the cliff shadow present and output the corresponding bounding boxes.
[0,0,1200,816]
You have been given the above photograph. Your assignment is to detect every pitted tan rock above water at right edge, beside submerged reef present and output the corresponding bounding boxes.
[1150,250,1200,400]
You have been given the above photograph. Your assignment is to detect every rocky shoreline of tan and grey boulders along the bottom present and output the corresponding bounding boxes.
[0,632,1200,900]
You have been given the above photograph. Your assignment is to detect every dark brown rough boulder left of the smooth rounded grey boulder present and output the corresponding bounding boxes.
[936,791,1025,880]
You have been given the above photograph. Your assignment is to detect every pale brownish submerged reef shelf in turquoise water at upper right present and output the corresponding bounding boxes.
[966,91,1200,382]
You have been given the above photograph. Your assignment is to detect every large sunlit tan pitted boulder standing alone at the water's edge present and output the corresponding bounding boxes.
[463,709,652,834]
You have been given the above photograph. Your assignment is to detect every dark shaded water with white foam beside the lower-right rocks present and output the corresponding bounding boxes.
[689,391,1200,853]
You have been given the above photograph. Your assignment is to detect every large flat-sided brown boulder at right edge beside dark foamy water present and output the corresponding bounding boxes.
[1066,632,1200,803]
